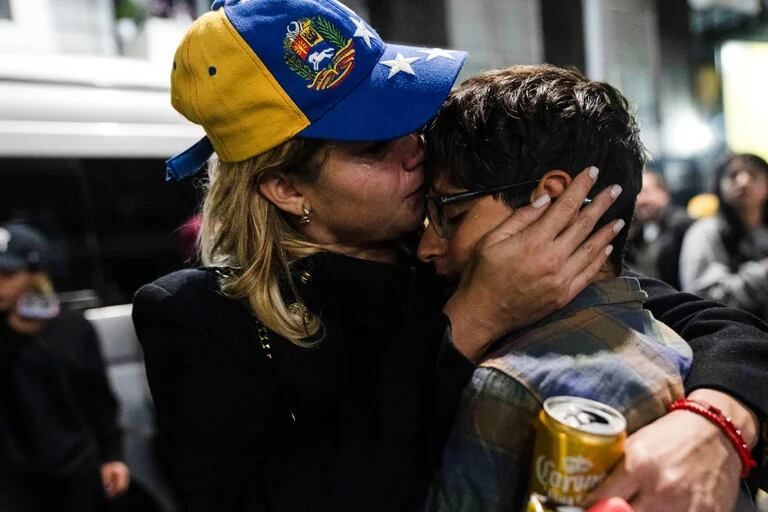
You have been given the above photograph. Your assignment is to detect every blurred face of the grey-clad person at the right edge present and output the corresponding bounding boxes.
[720,158,768,215]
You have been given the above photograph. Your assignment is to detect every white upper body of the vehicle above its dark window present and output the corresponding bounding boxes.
[0,54,202,158]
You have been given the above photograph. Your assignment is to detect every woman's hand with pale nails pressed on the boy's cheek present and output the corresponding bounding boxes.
[443,168,616,359]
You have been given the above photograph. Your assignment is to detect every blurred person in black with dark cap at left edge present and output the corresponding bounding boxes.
[0,223,129,512]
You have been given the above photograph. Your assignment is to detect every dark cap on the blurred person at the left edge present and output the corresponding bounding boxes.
[0,224,49,272]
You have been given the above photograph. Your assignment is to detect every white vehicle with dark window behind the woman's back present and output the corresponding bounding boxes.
[0,53,202,511]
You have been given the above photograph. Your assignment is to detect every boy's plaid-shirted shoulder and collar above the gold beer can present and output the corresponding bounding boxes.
[480,278,692,431]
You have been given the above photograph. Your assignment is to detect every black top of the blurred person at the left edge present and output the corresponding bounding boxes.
[0,313,121,478]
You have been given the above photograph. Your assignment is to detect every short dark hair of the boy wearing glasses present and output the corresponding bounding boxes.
[425,65,646,271]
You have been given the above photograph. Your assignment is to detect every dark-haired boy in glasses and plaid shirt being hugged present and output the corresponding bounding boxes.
[419,66,691,512]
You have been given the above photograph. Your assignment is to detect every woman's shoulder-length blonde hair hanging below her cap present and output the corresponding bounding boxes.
[200,139,325,346]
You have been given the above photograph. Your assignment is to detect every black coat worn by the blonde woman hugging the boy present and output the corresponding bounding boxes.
[134,254,768,512]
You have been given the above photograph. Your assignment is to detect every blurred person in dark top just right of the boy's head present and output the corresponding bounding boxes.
[626,169,693,288]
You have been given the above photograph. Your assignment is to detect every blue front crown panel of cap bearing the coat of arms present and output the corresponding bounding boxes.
[224,0,384,122]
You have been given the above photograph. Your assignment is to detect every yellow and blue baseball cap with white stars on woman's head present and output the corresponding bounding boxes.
[167,0,466,179]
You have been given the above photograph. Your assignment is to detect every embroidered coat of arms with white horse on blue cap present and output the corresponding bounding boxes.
[283,16,355,91]
